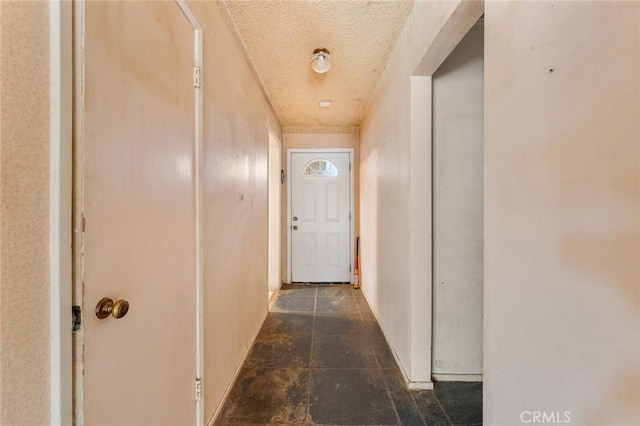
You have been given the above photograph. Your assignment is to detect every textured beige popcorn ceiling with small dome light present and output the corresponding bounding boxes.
[226,0,413,126]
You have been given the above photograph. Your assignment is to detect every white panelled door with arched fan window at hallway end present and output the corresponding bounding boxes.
[289,151,351,282]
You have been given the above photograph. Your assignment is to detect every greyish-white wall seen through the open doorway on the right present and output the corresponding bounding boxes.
[431,19,484,381]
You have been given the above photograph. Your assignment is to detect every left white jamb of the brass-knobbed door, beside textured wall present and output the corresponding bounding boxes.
[49,1,73,425]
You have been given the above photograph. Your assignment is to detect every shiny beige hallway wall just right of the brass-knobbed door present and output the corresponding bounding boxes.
[189,1,281,420]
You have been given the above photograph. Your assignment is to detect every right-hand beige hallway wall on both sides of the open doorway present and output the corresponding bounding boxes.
[360,2,640,425]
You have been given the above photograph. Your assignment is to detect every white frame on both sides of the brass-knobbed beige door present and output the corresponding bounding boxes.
[64,0,205,426]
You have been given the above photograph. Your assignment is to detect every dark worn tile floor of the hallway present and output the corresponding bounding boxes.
[216,284,482,426]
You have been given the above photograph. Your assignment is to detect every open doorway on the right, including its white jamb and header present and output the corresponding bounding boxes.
[408,10,484,389]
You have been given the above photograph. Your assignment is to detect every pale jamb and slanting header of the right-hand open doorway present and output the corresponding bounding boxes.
[405,2,484,389]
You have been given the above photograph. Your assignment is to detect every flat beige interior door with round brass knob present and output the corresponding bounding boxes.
[82,1,196,425]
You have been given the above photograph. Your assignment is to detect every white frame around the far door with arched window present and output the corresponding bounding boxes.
[287,148,355,283]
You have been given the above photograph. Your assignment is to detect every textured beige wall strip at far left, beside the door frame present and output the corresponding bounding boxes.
[0,1,49,425]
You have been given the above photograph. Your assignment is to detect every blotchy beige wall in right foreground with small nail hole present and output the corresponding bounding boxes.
[484,2,640,426]
